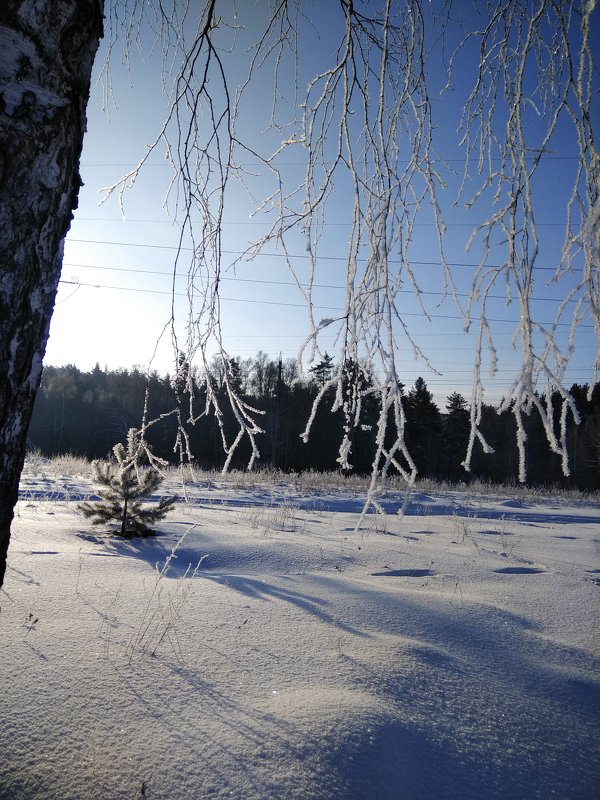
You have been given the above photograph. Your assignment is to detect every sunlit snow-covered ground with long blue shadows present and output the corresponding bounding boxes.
[0,472,600,800]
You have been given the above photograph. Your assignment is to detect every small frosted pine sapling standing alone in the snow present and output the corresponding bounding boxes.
[77,428,178,538]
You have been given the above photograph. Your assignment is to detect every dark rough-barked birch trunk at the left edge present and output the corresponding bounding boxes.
[0,0,103,586]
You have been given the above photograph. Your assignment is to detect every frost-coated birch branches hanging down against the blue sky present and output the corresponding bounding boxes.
[106,0,600,490]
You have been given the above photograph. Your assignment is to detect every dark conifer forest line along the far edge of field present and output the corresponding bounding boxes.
[28,351,600,489]
